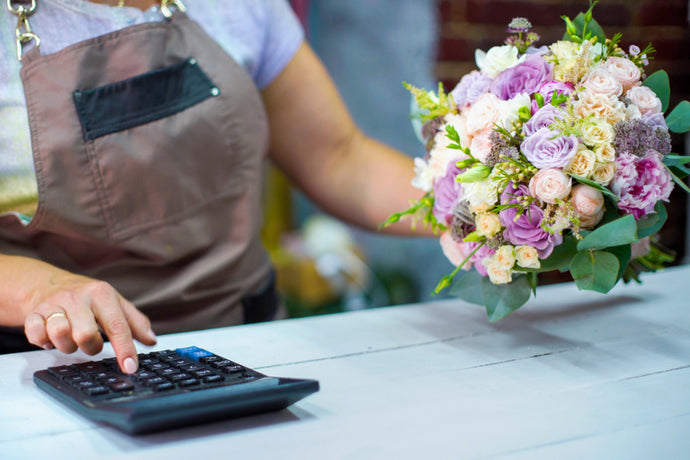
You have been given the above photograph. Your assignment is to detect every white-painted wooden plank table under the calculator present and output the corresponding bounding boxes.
[0,267,690,460]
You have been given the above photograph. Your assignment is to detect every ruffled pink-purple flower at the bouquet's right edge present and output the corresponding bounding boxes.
[611,150,673,219]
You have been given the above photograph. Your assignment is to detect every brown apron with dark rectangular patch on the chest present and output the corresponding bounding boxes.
[0,2,278,352]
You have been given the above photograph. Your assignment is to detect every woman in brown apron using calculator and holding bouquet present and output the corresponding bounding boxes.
[0,0,419,373]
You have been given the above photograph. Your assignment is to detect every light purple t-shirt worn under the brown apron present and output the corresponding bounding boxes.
[0,0,304,217]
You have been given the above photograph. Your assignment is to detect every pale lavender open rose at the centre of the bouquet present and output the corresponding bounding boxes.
[520,128,578,169]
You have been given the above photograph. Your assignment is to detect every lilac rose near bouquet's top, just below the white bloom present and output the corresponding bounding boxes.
[491,54,553,101]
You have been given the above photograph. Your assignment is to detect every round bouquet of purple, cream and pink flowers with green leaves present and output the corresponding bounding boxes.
[384,2,690,321]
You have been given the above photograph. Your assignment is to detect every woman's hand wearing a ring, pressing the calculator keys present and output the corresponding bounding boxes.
[0,256,156,374]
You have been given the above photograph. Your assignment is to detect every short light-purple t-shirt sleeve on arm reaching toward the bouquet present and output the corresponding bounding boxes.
[255,0,304,89]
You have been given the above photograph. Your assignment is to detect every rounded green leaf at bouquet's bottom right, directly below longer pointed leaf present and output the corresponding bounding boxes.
[570,251,620,294]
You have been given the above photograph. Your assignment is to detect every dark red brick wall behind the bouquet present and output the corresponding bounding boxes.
[435,0,690,276]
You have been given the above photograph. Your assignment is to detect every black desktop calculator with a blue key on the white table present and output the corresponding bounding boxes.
[34,346,319,434]
